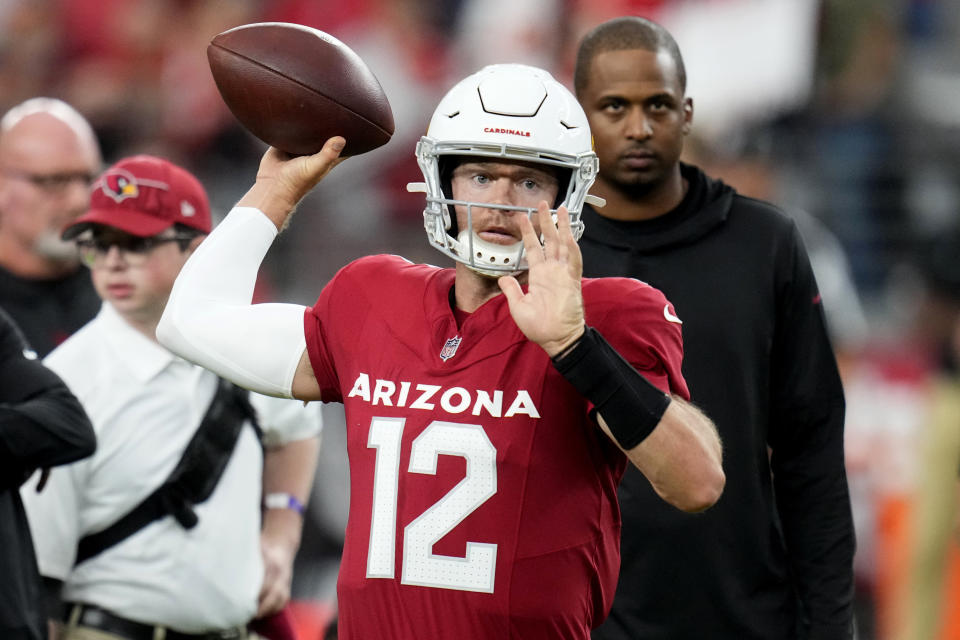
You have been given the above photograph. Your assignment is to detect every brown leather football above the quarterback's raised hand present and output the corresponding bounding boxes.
[207,22,393,156]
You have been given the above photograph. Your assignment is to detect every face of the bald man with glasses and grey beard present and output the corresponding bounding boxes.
[0,113,100,260]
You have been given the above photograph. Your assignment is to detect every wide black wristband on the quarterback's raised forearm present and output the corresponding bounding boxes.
[553,327,670,450]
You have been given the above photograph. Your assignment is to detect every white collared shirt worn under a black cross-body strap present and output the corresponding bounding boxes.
[21,304,320,632]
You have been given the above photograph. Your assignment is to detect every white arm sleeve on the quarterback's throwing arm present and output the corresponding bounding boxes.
[157,207,306,398]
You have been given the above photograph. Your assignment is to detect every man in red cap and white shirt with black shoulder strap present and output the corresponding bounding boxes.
[23,155,320,640]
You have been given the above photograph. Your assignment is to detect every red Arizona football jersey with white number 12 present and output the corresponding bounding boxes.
[305,256,688,640]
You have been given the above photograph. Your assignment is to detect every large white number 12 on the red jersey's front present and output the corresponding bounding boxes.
[367,418,497,593]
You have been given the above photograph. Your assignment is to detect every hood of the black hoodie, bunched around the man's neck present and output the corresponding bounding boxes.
[582,163,736,253]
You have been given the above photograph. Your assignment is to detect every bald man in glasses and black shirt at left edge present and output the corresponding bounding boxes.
[0,98,101,356]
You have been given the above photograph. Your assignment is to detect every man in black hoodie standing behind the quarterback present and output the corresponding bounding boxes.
[574,17,854,640]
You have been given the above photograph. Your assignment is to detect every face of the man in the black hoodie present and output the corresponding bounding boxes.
[580,49,693,193]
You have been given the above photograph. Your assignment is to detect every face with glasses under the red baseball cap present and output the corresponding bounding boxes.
[84,227,199,326]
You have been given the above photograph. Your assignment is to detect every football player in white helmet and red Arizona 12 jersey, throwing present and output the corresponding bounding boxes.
[158,65,724,640]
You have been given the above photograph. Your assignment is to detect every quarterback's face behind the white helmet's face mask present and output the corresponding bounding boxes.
[451,160,560,245]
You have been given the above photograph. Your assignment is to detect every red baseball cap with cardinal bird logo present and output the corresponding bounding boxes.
[62,155,211,240]
